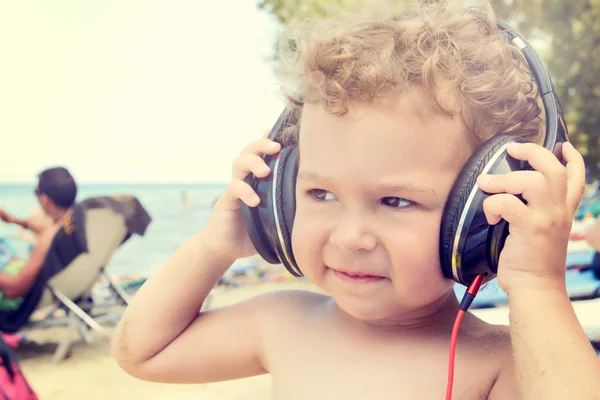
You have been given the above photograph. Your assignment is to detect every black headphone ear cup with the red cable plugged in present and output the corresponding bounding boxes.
[440,135,523,285]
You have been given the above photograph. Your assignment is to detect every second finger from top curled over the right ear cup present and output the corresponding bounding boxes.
[477,171,551,206]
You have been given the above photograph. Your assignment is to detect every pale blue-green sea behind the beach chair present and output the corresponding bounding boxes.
[0,183,226,275]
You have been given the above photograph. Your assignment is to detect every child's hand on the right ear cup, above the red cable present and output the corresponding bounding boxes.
[477,143,585,293]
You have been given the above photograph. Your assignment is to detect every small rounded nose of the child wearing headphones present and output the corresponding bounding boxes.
[329,212,377,251]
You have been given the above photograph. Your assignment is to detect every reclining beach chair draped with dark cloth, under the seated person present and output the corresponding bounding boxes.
[1,197,150,363]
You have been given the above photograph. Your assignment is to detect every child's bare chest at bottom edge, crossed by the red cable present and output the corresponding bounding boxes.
[269,330,497,400]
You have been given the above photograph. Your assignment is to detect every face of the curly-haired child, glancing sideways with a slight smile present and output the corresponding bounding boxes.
[292,94,471,320]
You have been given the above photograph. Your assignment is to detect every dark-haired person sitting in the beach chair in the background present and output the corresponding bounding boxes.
[0,167,77,309]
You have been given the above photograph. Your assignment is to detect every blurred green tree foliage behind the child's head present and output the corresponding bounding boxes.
[259,0,600,179]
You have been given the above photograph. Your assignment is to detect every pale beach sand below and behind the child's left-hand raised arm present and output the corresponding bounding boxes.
[17,280,314,400]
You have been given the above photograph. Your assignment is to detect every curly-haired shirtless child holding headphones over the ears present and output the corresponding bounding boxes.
[112,1,600,400]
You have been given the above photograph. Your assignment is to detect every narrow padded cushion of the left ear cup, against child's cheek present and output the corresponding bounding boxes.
[273,147,302,276]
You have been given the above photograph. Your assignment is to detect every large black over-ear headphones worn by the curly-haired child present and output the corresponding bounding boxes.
[242,11,568,286]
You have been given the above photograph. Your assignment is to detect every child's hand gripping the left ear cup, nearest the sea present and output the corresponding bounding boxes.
[201,135,281,262]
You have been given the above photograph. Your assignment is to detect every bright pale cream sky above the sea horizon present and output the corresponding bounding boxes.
[0,0,283,183]
